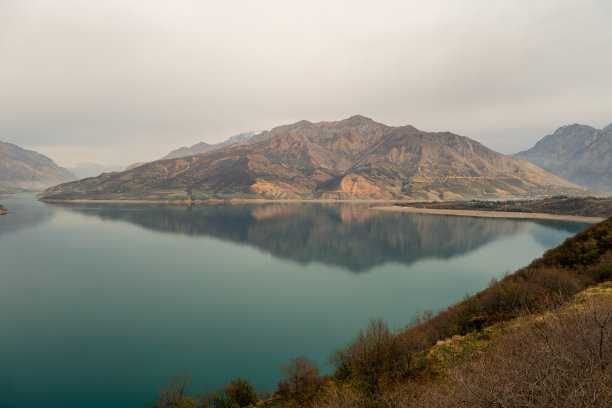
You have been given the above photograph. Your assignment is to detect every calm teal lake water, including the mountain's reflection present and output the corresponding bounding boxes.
[0,195,586,408]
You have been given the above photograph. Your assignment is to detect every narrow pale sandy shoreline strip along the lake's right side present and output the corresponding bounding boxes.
[372,206,605,223]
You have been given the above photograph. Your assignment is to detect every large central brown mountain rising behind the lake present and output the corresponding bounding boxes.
[43,116,577,201]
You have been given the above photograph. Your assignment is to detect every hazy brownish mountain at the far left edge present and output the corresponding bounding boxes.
[0,142,76,193]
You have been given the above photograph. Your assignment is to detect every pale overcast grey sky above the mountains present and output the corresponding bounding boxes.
[0,0,612,166]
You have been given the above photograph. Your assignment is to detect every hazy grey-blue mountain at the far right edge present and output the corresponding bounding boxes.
[516,124,612,192]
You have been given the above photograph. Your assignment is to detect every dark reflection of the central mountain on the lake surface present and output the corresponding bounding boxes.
[47,203,585,272]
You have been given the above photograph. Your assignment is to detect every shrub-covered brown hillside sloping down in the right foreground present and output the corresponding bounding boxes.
[152,218,612,408]
